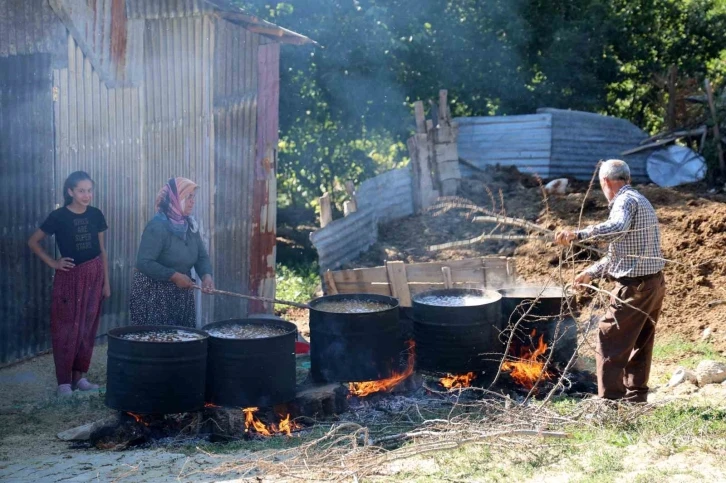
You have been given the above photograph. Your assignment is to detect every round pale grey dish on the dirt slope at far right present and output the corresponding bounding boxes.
[646,145,706,188]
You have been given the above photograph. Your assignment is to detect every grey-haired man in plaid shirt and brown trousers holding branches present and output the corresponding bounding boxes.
[555,159,665,402]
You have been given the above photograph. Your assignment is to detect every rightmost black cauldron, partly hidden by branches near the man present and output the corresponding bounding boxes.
[499,287,577,363]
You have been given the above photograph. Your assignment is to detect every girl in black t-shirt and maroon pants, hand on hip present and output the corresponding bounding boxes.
[28,171,111,396]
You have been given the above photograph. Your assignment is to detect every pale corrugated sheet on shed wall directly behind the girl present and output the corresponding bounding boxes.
[54,34,146,334]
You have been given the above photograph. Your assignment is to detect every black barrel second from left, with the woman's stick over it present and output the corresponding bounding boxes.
[203,316,297,407]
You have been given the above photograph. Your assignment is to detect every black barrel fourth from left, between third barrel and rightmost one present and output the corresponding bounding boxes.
[413,289,504,374]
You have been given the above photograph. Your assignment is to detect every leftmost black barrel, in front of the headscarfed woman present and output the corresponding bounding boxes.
[106,326,208,414]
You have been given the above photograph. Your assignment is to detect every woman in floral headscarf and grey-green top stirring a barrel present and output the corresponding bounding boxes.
[129,178,214,327]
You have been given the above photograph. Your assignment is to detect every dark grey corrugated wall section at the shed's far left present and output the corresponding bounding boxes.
[0,54,56,364]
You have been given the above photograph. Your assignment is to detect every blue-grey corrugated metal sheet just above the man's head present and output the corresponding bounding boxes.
[537,108,649,182]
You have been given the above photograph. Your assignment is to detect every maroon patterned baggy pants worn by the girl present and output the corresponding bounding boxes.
[50,257,103,385]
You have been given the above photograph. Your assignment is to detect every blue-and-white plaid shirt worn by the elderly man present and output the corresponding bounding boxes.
[575,185,665,278]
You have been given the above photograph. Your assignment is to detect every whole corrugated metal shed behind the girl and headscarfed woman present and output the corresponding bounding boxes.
[0,0,309,364]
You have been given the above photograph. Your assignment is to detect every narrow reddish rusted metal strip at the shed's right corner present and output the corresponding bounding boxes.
[249,43,280,312]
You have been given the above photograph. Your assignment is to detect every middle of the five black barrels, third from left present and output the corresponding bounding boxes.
[309,294,405,382]
